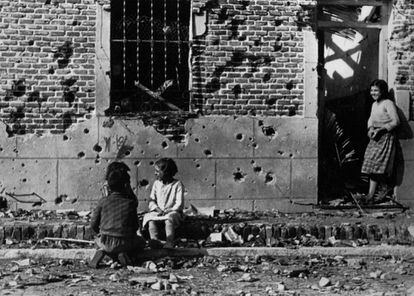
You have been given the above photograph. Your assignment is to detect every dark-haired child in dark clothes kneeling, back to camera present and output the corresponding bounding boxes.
[91,163,145,268]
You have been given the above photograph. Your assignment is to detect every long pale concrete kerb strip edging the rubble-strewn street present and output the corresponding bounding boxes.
[0,245,414,260]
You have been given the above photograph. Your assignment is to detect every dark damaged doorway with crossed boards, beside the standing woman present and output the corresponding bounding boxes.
[317,0,388,204]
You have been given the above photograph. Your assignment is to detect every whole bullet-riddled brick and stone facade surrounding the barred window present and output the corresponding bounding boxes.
[0,0,413,211]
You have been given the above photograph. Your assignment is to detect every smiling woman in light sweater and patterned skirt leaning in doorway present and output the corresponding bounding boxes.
[361,79,400,203]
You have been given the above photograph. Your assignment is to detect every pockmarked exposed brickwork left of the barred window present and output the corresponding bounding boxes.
[0,0,95,135]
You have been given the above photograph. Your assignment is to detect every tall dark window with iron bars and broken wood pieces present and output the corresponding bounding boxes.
[111,0,191,113]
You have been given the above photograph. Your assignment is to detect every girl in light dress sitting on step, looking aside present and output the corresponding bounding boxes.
[143,158,184,248]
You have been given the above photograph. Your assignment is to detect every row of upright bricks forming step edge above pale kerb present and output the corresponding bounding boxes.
[0,221,414,247]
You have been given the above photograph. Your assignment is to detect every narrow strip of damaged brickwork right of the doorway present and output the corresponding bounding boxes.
[389,0,414,120]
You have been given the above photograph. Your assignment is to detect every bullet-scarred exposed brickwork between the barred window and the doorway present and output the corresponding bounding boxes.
[192,0,312,116]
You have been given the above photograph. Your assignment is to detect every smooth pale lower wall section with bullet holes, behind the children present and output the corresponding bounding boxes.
[0,117,317,211]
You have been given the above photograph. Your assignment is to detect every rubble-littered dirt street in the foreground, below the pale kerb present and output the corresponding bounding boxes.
[0,252,414,296]
